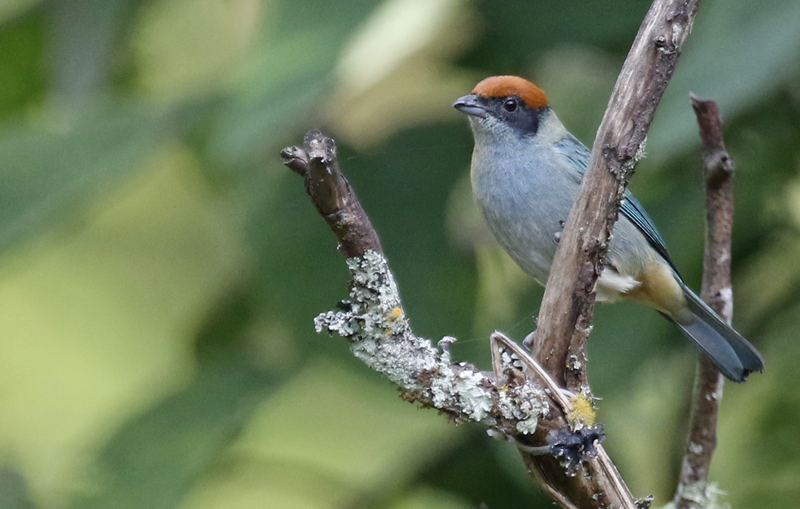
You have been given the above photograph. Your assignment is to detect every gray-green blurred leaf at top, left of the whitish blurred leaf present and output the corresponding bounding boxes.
[210,0,376,164]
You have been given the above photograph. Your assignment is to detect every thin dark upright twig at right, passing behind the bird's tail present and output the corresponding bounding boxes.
[675,95,734,509]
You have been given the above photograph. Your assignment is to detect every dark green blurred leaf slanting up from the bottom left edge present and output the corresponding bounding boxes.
[71,356,282,509]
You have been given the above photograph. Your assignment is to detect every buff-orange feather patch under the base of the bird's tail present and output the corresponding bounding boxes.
[625,262,686,322]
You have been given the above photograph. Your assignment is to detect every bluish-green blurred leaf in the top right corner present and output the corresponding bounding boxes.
[647,0,800,159]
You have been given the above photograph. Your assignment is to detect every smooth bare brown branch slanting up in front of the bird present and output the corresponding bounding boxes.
[534,0,700,392]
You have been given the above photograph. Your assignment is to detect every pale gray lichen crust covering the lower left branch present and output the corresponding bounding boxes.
[314,251,547,434]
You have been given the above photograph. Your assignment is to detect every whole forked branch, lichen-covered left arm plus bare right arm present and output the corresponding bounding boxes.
[282,0,699,509]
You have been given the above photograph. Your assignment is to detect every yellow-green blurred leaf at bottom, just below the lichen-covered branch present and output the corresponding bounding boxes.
[216,358,465,509]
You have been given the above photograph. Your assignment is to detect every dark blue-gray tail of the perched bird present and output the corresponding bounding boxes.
[675,282,764,382]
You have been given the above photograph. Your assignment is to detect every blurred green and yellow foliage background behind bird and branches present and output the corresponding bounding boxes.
[0,0,800,509]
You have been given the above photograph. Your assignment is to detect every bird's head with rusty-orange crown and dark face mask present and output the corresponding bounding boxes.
[453,76,549,139]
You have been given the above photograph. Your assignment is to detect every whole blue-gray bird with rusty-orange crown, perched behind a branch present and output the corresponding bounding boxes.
[453,76,764,382]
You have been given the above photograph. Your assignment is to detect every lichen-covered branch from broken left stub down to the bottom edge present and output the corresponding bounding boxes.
[281,131,636,509]
